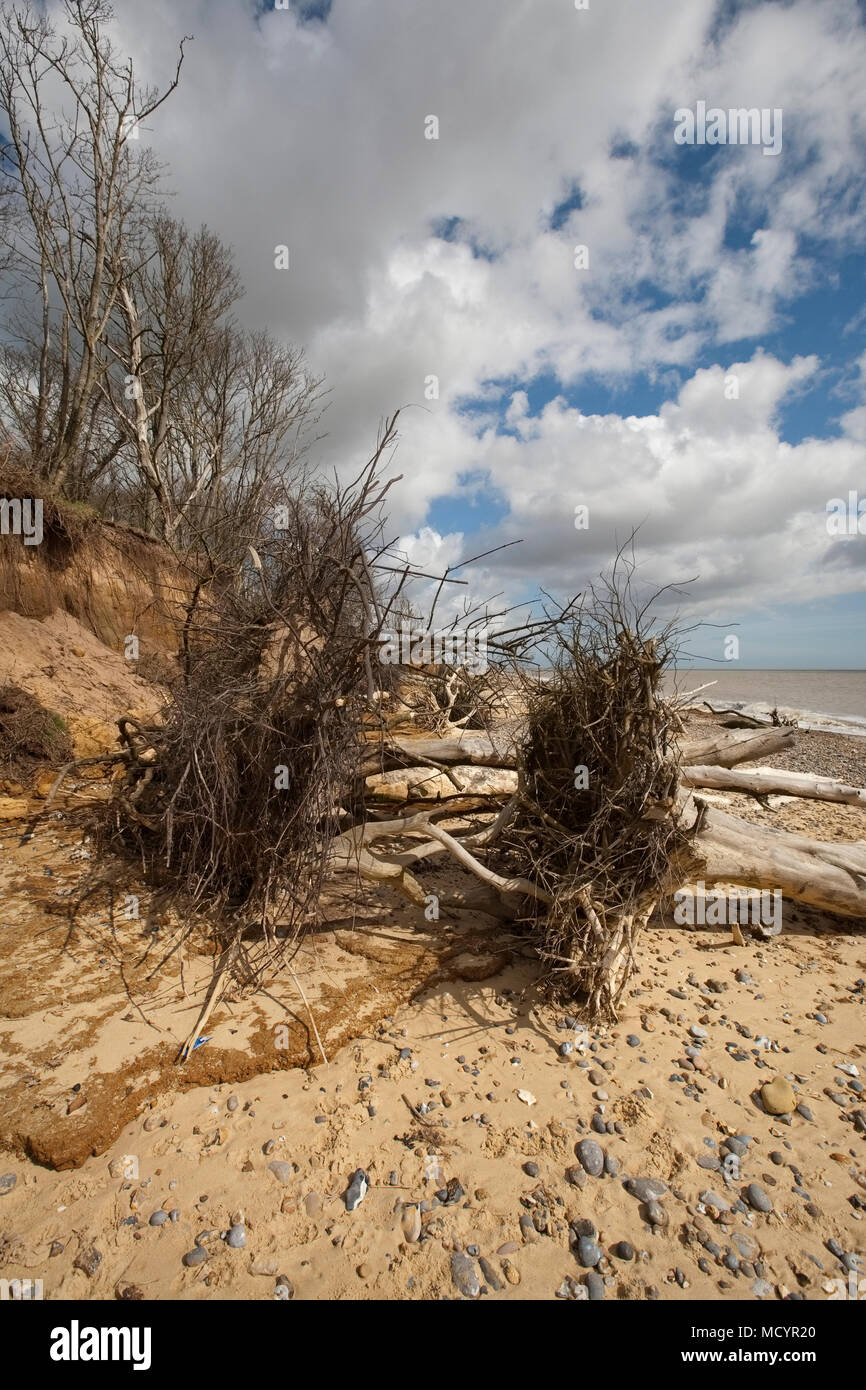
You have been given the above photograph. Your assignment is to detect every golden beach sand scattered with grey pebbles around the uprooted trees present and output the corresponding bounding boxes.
[0,678,866,1300]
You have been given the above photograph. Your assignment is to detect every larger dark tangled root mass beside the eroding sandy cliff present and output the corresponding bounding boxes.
[100,421,405,984]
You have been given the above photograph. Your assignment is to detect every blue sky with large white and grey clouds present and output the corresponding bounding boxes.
[76,0,866,669]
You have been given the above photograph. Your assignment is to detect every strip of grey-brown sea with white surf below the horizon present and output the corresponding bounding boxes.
[666,666,866,738]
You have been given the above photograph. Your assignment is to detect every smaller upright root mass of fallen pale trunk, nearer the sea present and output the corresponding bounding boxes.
[503,555,695,1017]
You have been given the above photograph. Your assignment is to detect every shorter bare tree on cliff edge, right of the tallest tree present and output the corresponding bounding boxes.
[101,213,320,559]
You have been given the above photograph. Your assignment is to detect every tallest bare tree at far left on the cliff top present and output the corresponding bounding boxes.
[0,0,185,487]
